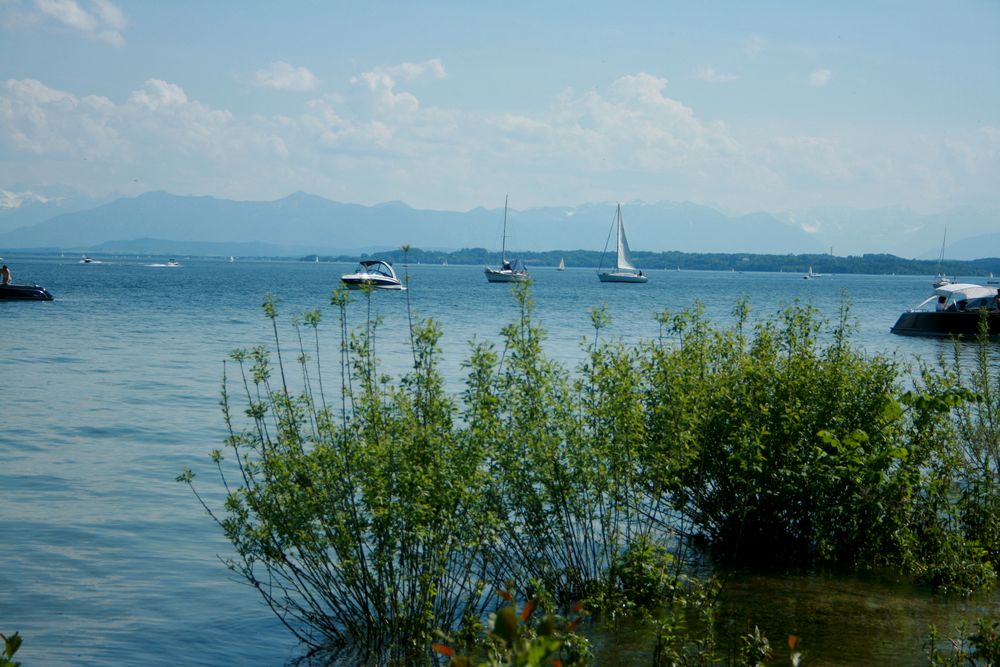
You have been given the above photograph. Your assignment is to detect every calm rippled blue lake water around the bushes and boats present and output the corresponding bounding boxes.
[0,255,1000,666]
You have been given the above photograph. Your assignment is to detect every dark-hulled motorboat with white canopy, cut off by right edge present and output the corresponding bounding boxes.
[890,283,1000,338]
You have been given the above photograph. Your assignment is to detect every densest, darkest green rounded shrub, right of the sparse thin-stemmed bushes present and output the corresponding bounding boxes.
[647,306,907,565]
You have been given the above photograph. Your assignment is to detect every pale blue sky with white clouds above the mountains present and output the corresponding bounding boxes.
[0,0,1000,214]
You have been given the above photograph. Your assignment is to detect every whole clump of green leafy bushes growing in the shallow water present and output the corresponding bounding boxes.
[178,284,1000,664]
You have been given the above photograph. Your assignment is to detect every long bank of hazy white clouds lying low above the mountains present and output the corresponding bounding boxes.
[0,68,1000,214]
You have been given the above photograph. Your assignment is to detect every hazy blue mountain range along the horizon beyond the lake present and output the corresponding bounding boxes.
[0,191,1000,259]
